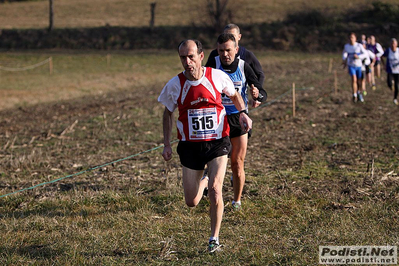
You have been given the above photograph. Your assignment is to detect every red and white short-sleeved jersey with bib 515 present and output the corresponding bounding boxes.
[158,65,236,142]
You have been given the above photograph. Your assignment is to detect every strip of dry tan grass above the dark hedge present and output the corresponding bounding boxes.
[0,0,397,29]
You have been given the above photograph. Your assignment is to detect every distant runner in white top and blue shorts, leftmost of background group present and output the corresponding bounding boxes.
[342,32,367,102]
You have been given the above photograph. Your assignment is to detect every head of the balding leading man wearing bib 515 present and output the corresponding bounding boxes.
[179,41,204,80]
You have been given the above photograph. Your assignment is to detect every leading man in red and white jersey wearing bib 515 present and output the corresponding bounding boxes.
[158,40,252,253]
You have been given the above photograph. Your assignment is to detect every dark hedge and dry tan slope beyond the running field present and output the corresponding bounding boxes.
[0,0,399,52]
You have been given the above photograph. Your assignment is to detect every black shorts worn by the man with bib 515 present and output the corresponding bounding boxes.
[177,137,231,170]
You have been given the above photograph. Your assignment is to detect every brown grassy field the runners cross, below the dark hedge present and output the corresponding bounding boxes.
[0,51,399,265]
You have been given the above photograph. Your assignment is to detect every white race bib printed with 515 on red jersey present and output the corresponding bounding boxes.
[188,107,218,140]
